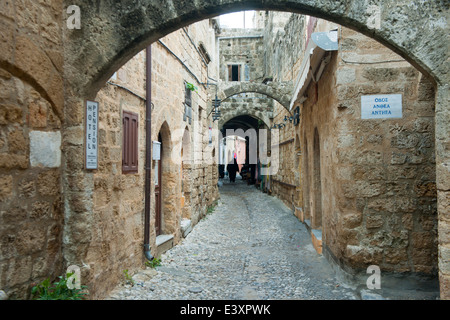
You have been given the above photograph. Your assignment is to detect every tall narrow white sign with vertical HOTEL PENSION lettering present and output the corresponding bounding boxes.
[85,100,98,170]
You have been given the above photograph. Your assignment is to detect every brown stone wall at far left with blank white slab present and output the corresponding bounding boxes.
[0,1,64,299]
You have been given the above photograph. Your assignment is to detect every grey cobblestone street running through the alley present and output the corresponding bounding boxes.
[109,179,357,300]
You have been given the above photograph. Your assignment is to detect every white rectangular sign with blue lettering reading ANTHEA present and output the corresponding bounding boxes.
[361,94,403,119]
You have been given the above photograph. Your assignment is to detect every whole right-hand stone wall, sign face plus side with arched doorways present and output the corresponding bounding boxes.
[266,12,437,274]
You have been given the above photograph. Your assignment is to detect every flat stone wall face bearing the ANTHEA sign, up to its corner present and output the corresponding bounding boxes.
[328,28,437,274]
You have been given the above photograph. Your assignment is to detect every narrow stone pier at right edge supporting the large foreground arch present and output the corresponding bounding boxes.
[435,82,450,300]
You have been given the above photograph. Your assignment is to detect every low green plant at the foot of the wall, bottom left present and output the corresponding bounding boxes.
[31,273,87,300]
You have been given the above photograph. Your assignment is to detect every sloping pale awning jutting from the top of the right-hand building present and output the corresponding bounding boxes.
[289,30,338,110]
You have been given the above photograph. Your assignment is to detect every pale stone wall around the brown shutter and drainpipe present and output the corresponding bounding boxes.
[84,21,218,298]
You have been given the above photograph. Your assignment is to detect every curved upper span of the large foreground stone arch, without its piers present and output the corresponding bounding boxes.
[65,0,448,97]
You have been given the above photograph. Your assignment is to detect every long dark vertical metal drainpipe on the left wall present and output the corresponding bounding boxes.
[144,45,154,261]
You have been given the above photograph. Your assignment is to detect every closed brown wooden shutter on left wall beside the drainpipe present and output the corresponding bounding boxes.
[122,111,139,173]
